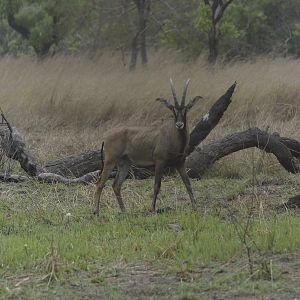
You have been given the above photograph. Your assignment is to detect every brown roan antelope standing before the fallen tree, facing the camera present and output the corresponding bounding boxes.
[94,79,202,215]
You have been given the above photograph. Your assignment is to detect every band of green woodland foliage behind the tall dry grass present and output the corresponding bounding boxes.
[0,0,300,59]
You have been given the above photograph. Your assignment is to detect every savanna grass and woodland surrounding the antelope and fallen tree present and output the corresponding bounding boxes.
[0,0,300,299]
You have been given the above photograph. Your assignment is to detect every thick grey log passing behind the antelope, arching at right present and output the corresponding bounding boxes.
[45,128,300,179]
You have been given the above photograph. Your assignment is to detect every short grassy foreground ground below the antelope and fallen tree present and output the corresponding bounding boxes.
[0,175,300,299]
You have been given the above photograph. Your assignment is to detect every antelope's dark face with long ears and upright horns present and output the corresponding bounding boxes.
[156,78,202,130]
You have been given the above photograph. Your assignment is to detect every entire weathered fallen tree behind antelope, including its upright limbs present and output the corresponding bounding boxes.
[0,84,300,184]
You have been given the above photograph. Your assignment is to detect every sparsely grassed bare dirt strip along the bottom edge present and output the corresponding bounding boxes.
[1,255,300,300]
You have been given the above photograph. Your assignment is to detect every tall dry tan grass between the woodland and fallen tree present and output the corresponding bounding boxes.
[0,53,300,166]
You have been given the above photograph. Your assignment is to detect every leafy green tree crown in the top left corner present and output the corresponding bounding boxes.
[2,0,80,57]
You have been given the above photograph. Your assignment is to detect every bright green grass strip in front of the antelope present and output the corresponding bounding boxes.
[0,207,300,271]
